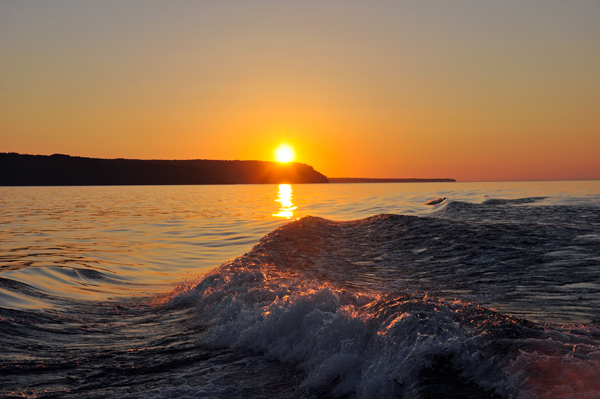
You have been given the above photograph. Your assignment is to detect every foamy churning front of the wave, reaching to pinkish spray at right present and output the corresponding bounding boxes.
[159,219,600,398]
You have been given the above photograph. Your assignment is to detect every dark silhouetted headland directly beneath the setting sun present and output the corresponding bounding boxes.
[0,152,328,186]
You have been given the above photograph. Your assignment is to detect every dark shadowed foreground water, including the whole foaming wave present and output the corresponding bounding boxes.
[0,184,600,398]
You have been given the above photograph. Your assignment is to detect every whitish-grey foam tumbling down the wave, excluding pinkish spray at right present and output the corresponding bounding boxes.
[165,264,512,398]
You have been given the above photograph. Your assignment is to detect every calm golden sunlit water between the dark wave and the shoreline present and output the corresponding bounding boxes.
[0,181,600,309]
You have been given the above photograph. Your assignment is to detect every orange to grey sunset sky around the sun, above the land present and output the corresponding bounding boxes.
[0,0,600,181]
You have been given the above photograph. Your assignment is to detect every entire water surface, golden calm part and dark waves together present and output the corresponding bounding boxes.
[0,181,600,398]
